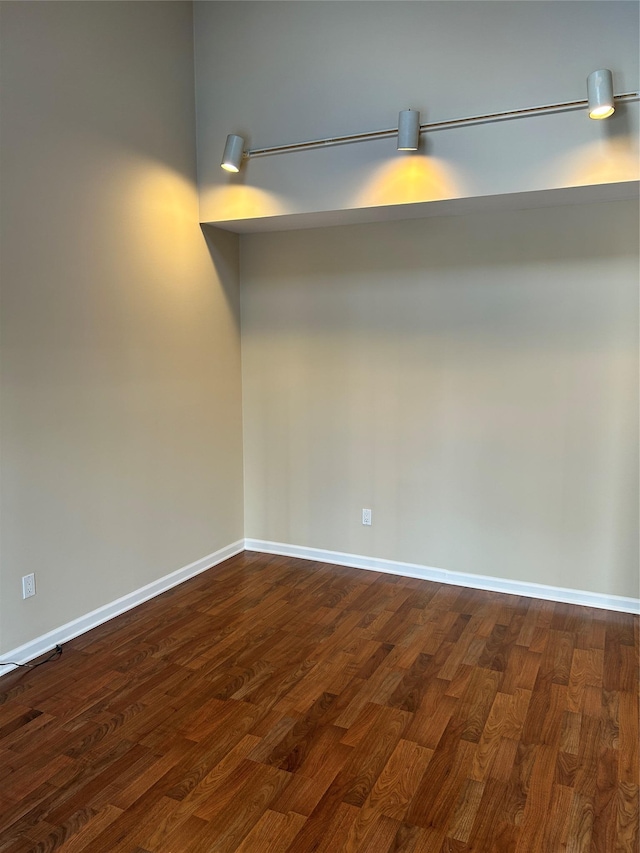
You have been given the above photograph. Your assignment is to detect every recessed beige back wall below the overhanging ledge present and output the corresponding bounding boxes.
[241,202,638,597]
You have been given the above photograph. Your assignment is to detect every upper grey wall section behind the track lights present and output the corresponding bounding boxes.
[195,0,639,226]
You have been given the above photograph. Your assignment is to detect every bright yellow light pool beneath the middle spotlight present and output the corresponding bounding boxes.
[354,157,462,207]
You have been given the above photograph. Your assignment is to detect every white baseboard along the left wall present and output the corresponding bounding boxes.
[0,539,245,676]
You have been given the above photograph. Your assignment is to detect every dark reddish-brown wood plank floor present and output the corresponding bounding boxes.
[0,553,639,853]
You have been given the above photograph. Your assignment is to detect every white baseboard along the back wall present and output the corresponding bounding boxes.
[244,539,640,613]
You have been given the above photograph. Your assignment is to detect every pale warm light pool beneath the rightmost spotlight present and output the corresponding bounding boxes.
[547,137,640,187]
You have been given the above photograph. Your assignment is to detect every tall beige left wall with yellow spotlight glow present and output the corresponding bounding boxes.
[0,2,243,651]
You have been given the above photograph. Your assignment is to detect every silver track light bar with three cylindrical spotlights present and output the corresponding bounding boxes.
[220,74,639,172]
